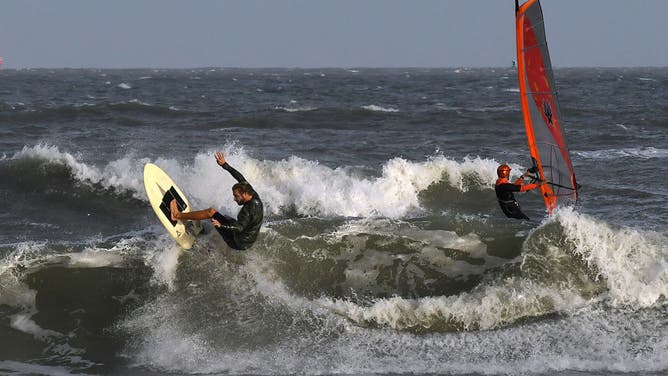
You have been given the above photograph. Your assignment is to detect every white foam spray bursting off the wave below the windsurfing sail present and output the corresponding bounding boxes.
[555,208,668,307]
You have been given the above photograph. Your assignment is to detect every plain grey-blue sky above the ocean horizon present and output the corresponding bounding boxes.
[0,0,668,68]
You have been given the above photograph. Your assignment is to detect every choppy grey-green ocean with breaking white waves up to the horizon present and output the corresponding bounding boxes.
[0,68,668,376]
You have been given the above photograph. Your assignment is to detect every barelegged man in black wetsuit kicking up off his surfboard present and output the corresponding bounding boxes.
[170,152,264,250]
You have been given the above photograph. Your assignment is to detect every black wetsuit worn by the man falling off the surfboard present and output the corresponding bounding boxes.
[213,163,264,250]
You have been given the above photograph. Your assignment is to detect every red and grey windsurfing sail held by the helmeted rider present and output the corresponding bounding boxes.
[515,0,578,214]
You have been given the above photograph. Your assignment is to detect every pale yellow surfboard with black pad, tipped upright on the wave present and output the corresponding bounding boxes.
[144,163,202,249]
